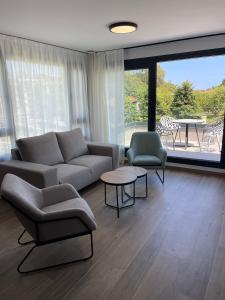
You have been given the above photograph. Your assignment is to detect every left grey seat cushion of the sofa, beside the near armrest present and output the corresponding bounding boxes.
[55,164,93,190]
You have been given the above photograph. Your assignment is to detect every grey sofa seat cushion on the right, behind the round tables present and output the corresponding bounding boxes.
[68,155,112,181]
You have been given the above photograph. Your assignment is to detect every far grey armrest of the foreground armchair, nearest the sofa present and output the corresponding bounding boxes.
[41,183,80,206]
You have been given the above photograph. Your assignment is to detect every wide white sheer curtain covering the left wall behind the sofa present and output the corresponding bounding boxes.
[0,35,89,158]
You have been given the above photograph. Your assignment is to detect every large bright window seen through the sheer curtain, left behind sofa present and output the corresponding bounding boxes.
[6,60,69,138]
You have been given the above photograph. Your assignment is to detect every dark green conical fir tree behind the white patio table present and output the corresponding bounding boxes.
[171,81,195,118]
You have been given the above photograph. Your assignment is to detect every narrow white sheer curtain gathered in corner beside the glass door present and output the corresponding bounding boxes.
[88,50,125,158]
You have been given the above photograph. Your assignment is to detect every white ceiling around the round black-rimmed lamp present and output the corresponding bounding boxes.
[0,0,225,51]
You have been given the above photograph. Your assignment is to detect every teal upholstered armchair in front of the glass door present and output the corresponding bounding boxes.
[127,131,167,183]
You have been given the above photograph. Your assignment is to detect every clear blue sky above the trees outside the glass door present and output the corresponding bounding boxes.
[160,55,225,90]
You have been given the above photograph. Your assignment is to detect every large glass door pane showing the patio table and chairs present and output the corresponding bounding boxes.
[156,55,225,162]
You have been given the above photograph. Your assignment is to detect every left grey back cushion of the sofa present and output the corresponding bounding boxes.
[16,132,64,166]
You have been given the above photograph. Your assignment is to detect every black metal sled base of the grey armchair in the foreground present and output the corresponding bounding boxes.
[17,232,94,274]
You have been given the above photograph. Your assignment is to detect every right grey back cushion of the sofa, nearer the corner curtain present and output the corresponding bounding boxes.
[56,128,88,162]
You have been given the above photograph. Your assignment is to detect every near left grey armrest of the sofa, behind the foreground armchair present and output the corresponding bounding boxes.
[0,160,58,188]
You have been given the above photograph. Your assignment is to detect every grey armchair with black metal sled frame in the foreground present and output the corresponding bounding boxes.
[1,174,96,273]
